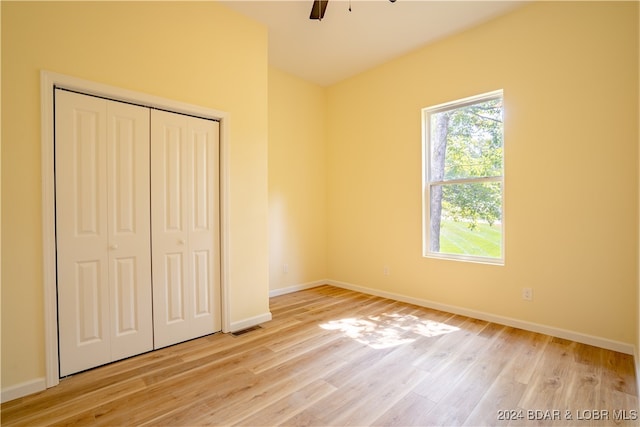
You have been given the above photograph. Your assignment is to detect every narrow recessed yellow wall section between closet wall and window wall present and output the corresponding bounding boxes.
[269,67,327,290]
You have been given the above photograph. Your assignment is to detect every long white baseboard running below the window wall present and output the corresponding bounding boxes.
[323,280,638,356]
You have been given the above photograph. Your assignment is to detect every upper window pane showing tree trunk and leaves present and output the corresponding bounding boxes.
[429,98,503,181]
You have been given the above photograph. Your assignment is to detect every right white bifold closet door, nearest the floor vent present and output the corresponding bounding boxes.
[151,110,221,348]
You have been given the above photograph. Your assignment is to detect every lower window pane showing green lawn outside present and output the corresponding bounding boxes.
[429,182,502,258]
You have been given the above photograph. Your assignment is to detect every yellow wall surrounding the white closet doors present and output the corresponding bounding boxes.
[1,1,269,389]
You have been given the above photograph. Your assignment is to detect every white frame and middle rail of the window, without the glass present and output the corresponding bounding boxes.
[422,89,506,265]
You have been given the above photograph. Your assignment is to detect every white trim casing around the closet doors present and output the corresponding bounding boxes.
[40,70,231,388]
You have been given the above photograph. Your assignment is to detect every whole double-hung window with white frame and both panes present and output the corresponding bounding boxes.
[423,90,504,264]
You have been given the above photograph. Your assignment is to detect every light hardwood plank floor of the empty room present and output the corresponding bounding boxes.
[1,286,639,426]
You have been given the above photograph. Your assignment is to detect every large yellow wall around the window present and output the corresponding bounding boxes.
[327,2,639,344]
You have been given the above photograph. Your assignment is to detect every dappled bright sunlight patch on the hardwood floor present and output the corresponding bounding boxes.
[320,313,460,349]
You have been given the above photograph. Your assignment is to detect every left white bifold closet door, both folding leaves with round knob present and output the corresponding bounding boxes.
[55,90,153,376]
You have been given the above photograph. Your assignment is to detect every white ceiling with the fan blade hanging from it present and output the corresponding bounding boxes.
[221,0,524,86]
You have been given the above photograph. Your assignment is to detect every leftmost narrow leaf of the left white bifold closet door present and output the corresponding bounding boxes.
[55,91,111,376]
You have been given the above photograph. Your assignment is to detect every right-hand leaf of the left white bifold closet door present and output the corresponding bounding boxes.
[107,102,153,360]
